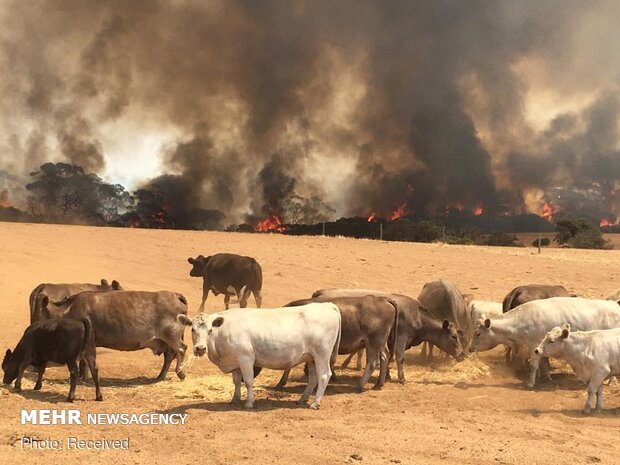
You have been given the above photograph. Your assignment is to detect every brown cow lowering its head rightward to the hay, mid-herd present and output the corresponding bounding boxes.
[312,288,463,384]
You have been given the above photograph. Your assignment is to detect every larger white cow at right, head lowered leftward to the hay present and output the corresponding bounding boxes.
[470,297,620,387]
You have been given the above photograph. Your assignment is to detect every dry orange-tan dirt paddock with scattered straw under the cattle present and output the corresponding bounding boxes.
[0,223,620,465]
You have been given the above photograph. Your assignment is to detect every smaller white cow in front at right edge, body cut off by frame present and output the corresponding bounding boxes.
[534,324,620,414]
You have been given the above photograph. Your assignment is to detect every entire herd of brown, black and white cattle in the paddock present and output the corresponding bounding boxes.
[2,254,620,413]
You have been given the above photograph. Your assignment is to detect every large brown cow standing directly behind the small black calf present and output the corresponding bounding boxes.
[44,291,187,381]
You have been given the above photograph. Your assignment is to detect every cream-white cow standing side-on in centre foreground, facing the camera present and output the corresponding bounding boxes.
[178,302,341,409]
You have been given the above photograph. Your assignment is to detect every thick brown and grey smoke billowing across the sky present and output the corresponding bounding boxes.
[0,0,620,222]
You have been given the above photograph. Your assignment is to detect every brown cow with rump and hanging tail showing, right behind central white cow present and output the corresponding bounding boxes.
[278,295,398,392]
